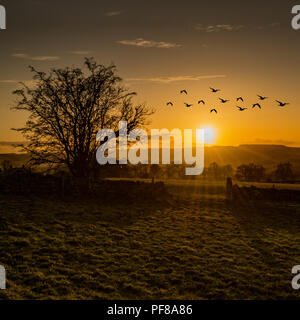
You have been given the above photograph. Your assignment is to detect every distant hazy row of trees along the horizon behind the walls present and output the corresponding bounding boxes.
[0,160,299,183]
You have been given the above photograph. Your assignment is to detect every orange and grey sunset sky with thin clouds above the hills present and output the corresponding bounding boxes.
[0,0,300,146]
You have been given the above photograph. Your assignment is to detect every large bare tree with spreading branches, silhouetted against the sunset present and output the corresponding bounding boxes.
[12,58,153,178]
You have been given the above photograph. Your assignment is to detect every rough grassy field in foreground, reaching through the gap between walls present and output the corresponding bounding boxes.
[0,181,300,299]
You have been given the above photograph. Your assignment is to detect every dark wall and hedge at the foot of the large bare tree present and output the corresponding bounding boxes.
[0,161,169,205]
